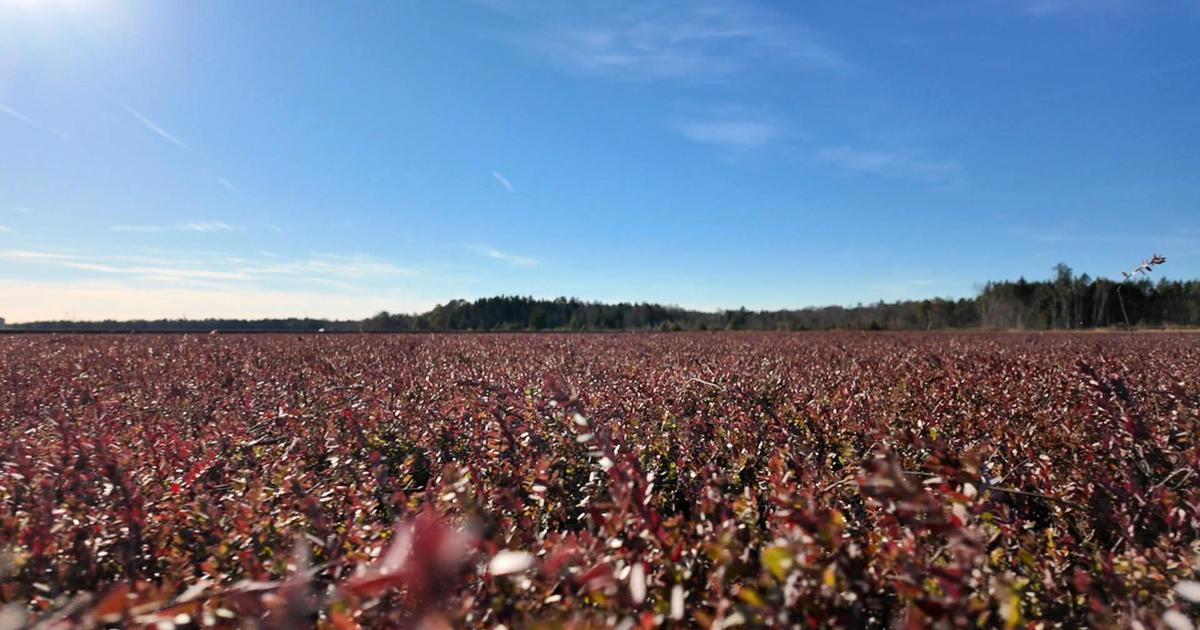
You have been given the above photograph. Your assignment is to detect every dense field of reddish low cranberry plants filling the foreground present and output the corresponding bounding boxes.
[0,334,1200,629]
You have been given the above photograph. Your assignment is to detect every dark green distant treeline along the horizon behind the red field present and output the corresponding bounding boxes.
[9,265,1200,332]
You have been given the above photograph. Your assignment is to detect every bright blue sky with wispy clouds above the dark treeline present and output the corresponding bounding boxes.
[0,0,1200,320]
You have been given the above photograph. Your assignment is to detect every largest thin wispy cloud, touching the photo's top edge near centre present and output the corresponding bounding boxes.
[492,0,850,79]
